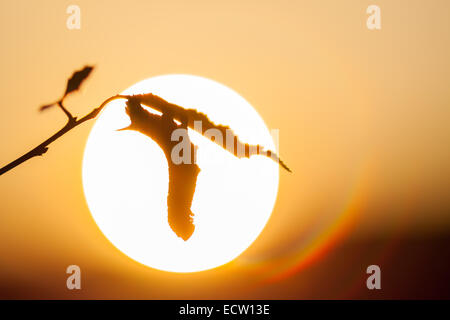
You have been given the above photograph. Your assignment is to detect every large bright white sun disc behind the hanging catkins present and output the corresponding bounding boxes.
[83,75,279,272]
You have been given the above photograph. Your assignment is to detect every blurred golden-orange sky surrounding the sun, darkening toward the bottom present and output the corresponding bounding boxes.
[0,0,450,299]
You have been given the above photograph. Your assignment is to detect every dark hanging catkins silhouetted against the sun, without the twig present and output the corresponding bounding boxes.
[119,93,291,241]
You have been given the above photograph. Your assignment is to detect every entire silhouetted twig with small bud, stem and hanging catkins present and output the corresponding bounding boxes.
[0,66,291,241]
